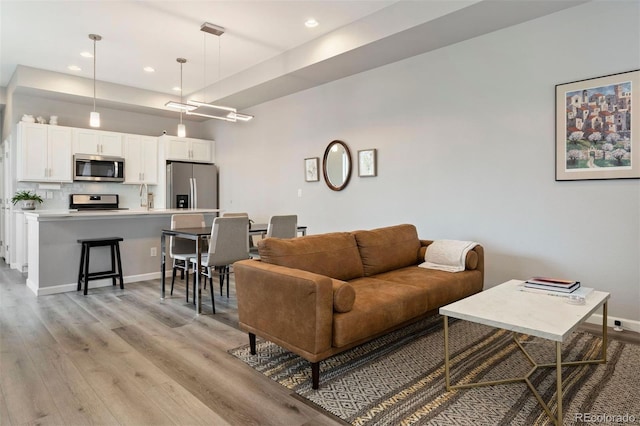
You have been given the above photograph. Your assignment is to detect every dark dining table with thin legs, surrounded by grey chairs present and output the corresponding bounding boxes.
[160,223,307,315]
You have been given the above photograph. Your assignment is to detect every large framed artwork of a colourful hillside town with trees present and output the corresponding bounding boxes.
[556,70,640,181]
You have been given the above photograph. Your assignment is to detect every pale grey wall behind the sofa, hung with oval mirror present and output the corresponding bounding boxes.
[212,1,640,321]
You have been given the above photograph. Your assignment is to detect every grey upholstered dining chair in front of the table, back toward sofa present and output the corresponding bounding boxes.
[191,216,249,314]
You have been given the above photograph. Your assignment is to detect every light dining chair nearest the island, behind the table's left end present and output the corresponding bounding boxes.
[169,213,205,302]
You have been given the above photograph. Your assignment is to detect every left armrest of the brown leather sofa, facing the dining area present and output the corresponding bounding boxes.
[233,260,333,362]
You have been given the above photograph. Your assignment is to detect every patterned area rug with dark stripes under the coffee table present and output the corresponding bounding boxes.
[229,316,640,425]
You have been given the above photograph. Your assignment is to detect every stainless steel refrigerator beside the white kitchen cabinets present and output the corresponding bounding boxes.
[167,161,218,209]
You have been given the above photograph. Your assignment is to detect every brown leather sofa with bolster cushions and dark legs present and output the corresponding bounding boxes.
[234,225,484,389]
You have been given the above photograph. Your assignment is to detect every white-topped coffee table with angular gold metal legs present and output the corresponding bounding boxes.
[440,280,610,425]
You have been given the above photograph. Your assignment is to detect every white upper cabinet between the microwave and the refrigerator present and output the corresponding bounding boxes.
[124,135,158,185]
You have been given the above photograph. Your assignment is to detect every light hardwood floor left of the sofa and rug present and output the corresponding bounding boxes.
[0,260,341,426]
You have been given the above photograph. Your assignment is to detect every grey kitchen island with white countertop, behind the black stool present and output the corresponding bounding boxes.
[25,209,220,296]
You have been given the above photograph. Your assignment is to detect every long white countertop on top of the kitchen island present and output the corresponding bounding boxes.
[24,208,222,222]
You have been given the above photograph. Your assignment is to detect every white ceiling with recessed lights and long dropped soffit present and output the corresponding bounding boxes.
[0,0,585,112]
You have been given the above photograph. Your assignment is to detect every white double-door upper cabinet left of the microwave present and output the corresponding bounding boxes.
[17,122,72,182]
